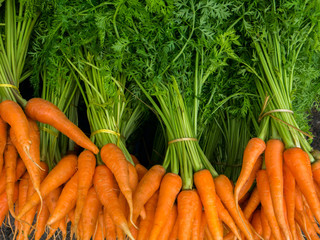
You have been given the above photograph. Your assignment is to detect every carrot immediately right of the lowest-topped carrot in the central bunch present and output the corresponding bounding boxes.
[193,169,223,240]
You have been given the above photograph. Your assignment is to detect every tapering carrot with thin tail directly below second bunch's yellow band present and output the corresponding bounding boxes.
[100,143,133,225]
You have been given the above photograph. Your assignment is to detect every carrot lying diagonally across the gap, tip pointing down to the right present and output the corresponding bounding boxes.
[25,98,99,154]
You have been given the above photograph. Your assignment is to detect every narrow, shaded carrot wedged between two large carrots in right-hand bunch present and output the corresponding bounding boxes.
[283,164,297,240]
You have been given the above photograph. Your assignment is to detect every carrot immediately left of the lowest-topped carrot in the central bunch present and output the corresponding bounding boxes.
[150,173,181,240]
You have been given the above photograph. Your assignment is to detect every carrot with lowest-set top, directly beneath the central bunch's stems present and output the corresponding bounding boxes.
[177,190,199,240]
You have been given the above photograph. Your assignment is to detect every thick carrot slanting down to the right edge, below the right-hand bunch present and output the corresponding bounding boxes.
[284,148,320,222]
